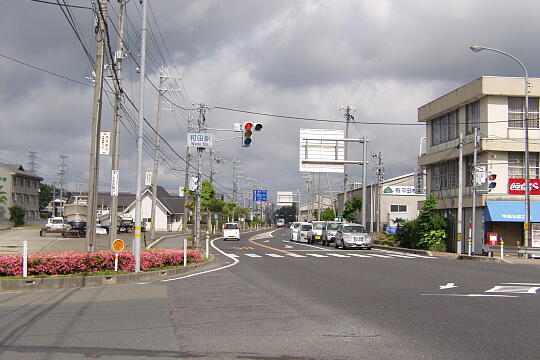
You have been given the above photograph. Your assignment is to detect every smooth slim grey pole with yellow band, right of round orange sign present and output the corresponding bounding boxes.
[133,0,148,272]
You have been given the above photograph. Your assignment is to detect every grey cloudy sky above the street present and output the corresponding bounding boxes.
[0,0,540,202]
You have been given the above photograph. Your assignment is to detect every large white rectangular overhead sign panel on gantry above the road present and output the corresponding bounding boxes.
[300,129,345,173]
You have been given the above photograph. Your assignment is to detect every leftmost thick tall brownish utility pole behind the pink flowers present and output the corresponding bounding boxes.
[86,0,107,252]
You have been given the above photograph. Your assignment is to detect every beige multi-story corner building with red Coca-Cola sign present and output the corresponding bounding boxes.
[418,77,540,254]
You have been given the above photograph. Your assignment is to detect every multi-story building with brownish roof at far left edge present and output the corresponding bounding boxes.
[0,164,43,220]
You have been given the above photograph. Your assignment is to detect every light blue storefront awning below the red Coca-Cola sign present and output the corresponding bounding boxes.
[484,200,540,222]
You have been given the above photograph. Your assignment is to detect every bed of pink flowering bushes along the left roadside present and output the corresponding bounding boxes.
[0,249,202,276]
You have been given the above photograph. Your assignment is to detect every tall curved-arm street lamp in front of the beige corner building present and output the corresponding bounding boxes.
[470,46,532,250]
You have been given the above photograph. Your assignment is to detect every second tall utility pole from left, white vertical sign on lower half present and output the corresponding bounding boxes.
[109,0,126,249]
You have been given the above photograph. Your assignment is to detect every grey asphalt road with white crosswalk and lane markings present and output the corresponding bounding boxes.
[0,230,540,359]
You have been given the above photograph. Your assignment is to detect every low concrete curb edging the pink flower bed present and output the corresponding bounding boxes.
[0,255,215,292]
